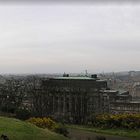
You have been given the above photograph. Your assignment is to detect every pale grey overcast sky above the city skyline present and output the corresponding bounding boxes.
[0,3,140,73]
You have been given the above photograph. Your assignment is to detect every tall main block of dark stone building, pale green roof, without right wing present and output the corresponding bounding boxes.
[42,75,107,123]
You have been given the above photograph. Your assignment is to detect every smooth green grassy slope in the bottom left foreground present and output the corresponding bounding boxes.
[0,117,68,140]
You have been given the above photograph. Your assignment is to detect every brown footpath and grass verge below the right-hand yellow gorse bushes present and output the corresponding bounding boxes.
[67,125,140,140]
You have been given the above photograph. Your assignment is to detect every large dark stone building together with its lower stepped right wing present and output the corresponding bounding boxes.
[29,74,140,123]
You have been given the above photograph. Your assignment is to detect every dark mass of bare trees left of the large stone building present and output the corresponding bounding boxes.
[0,75,43,114]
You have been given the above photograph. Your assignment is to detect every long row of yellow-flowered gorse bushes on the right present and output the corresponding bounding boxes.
[90,114,140,130]
